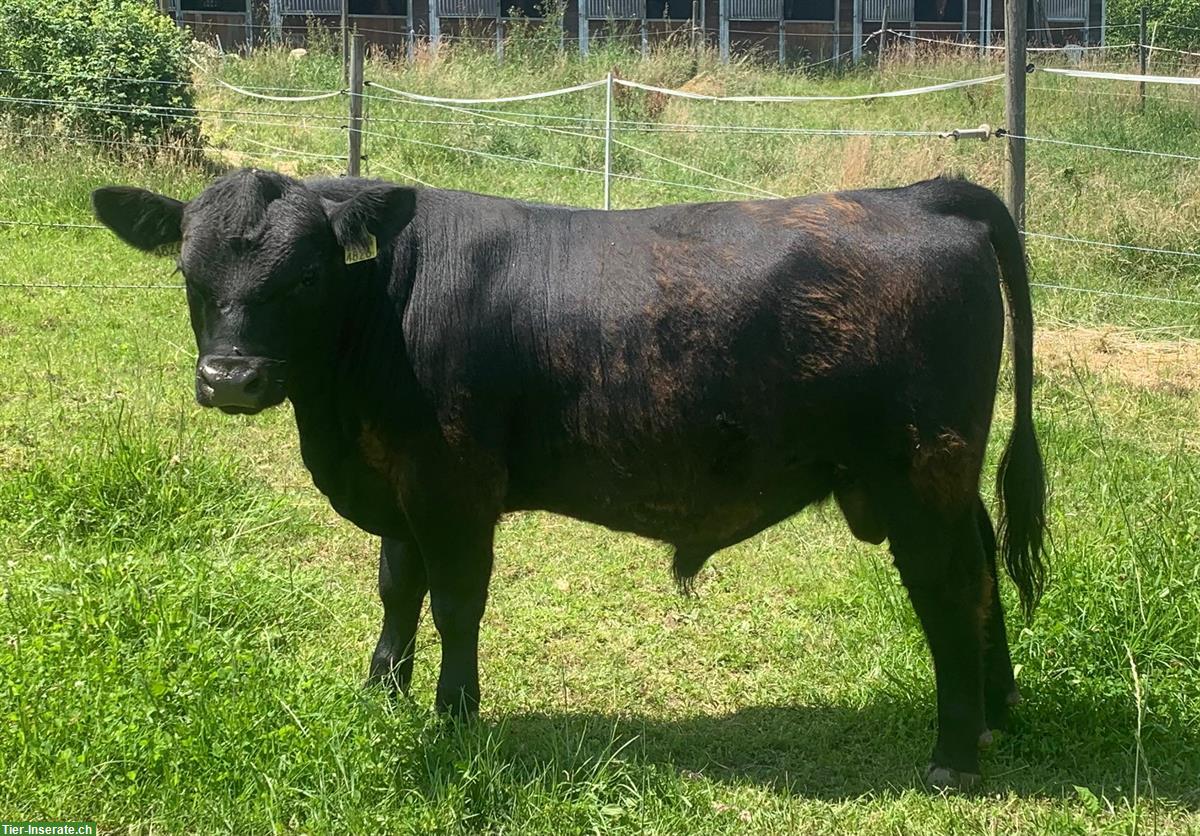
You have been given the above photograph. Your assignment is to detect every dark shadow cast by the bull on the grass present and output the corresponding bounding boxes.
[485,687,1200,811]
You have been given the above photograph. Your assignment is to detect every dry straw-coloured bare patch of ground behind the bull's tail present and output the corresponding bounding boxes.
[1034,327,1200,395]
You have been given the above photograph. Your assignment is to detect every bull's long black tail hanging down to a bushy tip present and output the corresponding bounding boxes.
[921,180,1046,618]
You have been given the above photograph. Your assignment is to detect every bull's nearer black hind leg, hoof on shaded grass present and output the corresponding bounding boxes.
[888,488,991,788]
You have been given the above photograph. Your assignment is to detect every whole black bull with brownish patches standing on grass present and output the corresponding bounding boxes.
[92,170,1045,786]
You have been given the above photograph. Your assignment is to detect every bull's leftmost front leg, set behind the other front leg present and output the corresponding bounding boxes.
[367,537,428,693]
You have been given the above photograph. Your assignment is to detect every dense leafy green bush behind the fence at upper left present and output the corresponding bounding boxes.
[0,0,199,143]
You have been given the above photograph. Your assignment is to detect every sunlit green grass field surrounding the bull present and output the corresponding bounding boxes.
[0,38,1200,834]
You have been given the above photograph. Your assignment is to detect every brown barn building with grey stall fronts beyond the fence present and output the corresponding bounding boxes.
[170,0,1105,64]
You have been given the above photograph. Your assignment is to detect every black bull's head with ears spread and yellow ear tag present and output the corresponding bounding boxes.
[91,169,415,414]
